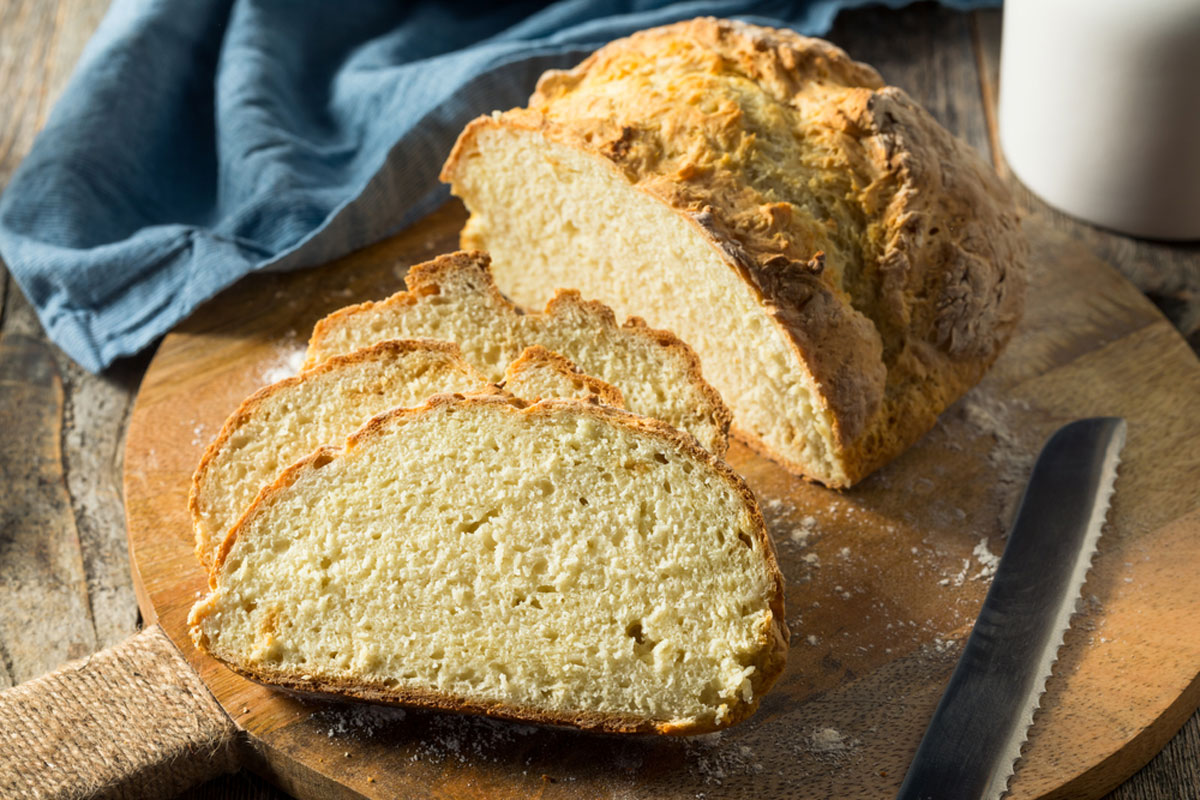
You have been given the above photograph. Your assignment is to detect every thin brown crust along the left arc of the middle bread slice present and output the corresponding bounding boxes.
[187,339,487,570]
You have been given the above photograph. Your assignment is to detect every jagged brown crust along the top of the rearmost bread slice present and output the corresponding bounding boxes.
[305,251,733,456]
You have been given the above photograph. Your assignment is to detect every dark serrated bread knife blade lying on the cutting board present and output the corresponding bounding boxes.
[896,417,1126,800]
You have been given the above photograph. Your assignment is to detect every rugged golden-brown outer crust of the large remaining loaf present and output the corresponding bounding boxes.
[442,18,1027,486]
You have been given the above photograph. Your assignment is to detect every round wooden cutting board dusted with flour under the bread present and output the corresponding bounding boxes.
[125,204,1200,800]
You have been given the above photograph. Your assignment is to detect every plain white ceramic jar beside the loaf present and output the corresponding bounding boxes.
[1000,0,1200,240]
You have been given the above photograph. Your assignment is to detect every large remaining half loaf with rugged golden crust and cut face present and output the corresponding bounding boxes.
[443,19,1026,487]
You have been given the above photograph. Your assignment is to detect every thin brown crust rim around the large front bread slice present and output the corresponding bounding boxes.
[188,390,790,735]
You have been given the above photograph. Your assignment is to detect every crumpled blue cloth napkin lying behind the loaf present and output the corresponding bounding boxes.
[0,0,991,371]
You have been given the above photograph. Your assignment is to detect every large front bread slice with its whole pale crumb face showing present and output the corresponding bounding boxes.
[190,395,787,734]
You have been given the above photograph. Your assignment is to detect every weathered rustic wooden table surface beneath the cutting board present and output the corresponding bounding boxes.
[0,0,1200,800]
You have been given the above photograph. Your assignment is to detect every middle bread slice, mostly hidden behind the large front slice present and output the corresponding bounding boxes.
[188,339,622,567]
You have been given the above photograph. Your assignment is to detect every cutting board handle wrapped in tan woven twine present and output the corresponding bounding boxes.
[0,625,238,800]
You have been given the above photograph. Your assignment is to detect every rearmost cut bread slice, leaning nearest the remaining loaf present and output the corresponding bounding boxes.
[307,252,730,456]
